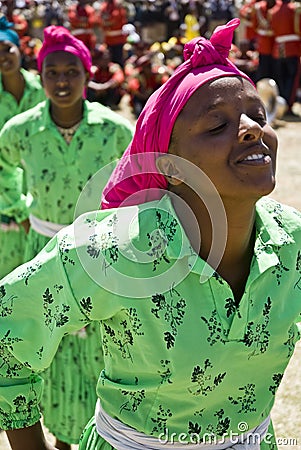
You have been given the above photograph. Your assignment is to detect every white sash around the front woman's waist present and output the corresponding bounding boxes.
[95,400,271,450]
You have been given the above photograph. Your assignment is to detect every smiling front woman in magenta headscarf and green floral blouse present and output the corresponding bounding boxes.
[0,19,301,450]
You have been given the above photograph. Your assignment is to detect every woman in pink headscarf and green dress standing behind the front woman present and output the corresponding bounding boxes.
[0,26,132,449]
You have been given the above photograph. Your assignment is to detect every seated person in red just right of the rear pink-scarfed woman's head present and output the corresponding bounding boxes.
[87,45,124,109]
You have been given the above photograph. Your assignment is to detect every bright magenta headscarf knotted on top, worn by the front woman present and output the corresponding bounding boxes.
[101,19,254,209]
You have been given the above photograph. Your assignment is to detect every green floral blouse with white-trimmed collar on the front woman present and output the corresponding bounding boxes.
[0,196,301,450]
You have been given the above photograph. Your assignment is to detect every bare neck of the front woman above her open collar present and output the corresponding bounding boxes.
[173,188,256,301]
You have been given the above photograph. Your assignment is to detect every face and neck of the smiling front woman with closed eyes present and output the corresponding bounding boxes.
[157,77,277,303]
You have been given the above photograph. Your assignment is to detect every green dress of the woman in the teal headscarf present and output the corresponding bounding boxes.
[0,68,45,278]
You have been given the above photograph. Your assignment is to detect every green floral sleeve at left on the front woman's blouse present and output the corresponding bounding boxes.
[0,232,89,429]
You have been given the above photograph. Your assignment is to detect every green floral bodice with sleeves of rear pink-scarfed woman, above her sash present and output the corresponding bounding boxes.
[0,100,132,224]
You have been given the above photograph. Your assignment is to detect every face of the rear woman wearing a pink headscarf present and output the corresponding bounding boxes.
[41,51,89,108]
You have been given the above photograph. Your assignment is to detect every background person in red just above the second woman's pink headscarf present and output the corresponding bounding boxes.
[68,0,97,51]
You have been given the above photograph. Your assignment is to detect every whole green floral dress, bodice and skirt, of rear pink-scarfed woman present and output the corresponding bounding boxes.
[0,100,133,444]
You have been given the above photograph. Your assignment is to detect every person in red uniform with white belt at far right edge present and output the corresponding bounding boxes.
[270,0,301,115]
